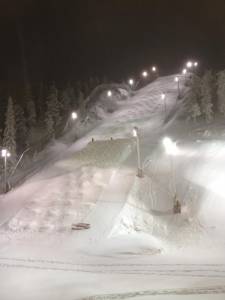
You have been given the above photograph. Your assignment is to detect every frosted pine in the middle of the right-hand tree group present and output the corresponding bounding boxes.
[200,71,214,122]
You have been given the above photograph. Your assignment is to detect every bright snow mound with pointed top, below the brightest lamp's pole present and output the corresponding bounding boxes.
[111,177,204,251]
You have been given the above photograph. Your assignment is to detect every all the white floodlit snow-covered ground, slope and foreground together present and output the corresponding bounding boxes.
[0,76,225,300]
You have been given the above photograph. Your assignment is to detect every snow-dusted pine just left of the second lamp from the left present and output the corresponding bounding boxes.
[47,84,62,127]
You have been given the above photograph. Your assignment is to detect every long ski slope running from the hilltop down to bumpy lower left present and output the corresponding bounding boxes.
[2,76,180,236]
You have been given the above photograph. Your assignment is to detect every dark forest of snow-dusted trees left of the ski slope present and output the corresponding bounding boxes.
[0,78,106,167]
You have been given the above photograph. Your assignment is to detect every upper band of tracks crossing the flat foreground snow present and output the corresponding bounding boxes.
[0,257,225,278]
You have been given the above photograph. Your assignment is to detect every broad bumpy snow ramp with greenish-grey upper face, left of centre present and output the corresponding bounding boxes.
[1,138,134,236]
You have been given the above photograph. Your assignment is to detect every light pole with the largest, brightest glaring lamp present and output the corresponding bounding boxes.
[163,137,181,214]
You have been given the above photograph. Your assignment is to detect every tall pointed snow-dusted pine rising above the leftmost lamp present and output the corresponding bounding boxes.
[3,97,16,162]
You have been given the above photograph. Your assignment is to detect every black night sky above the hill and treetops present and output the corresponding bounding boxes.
[0,0,225,81]
